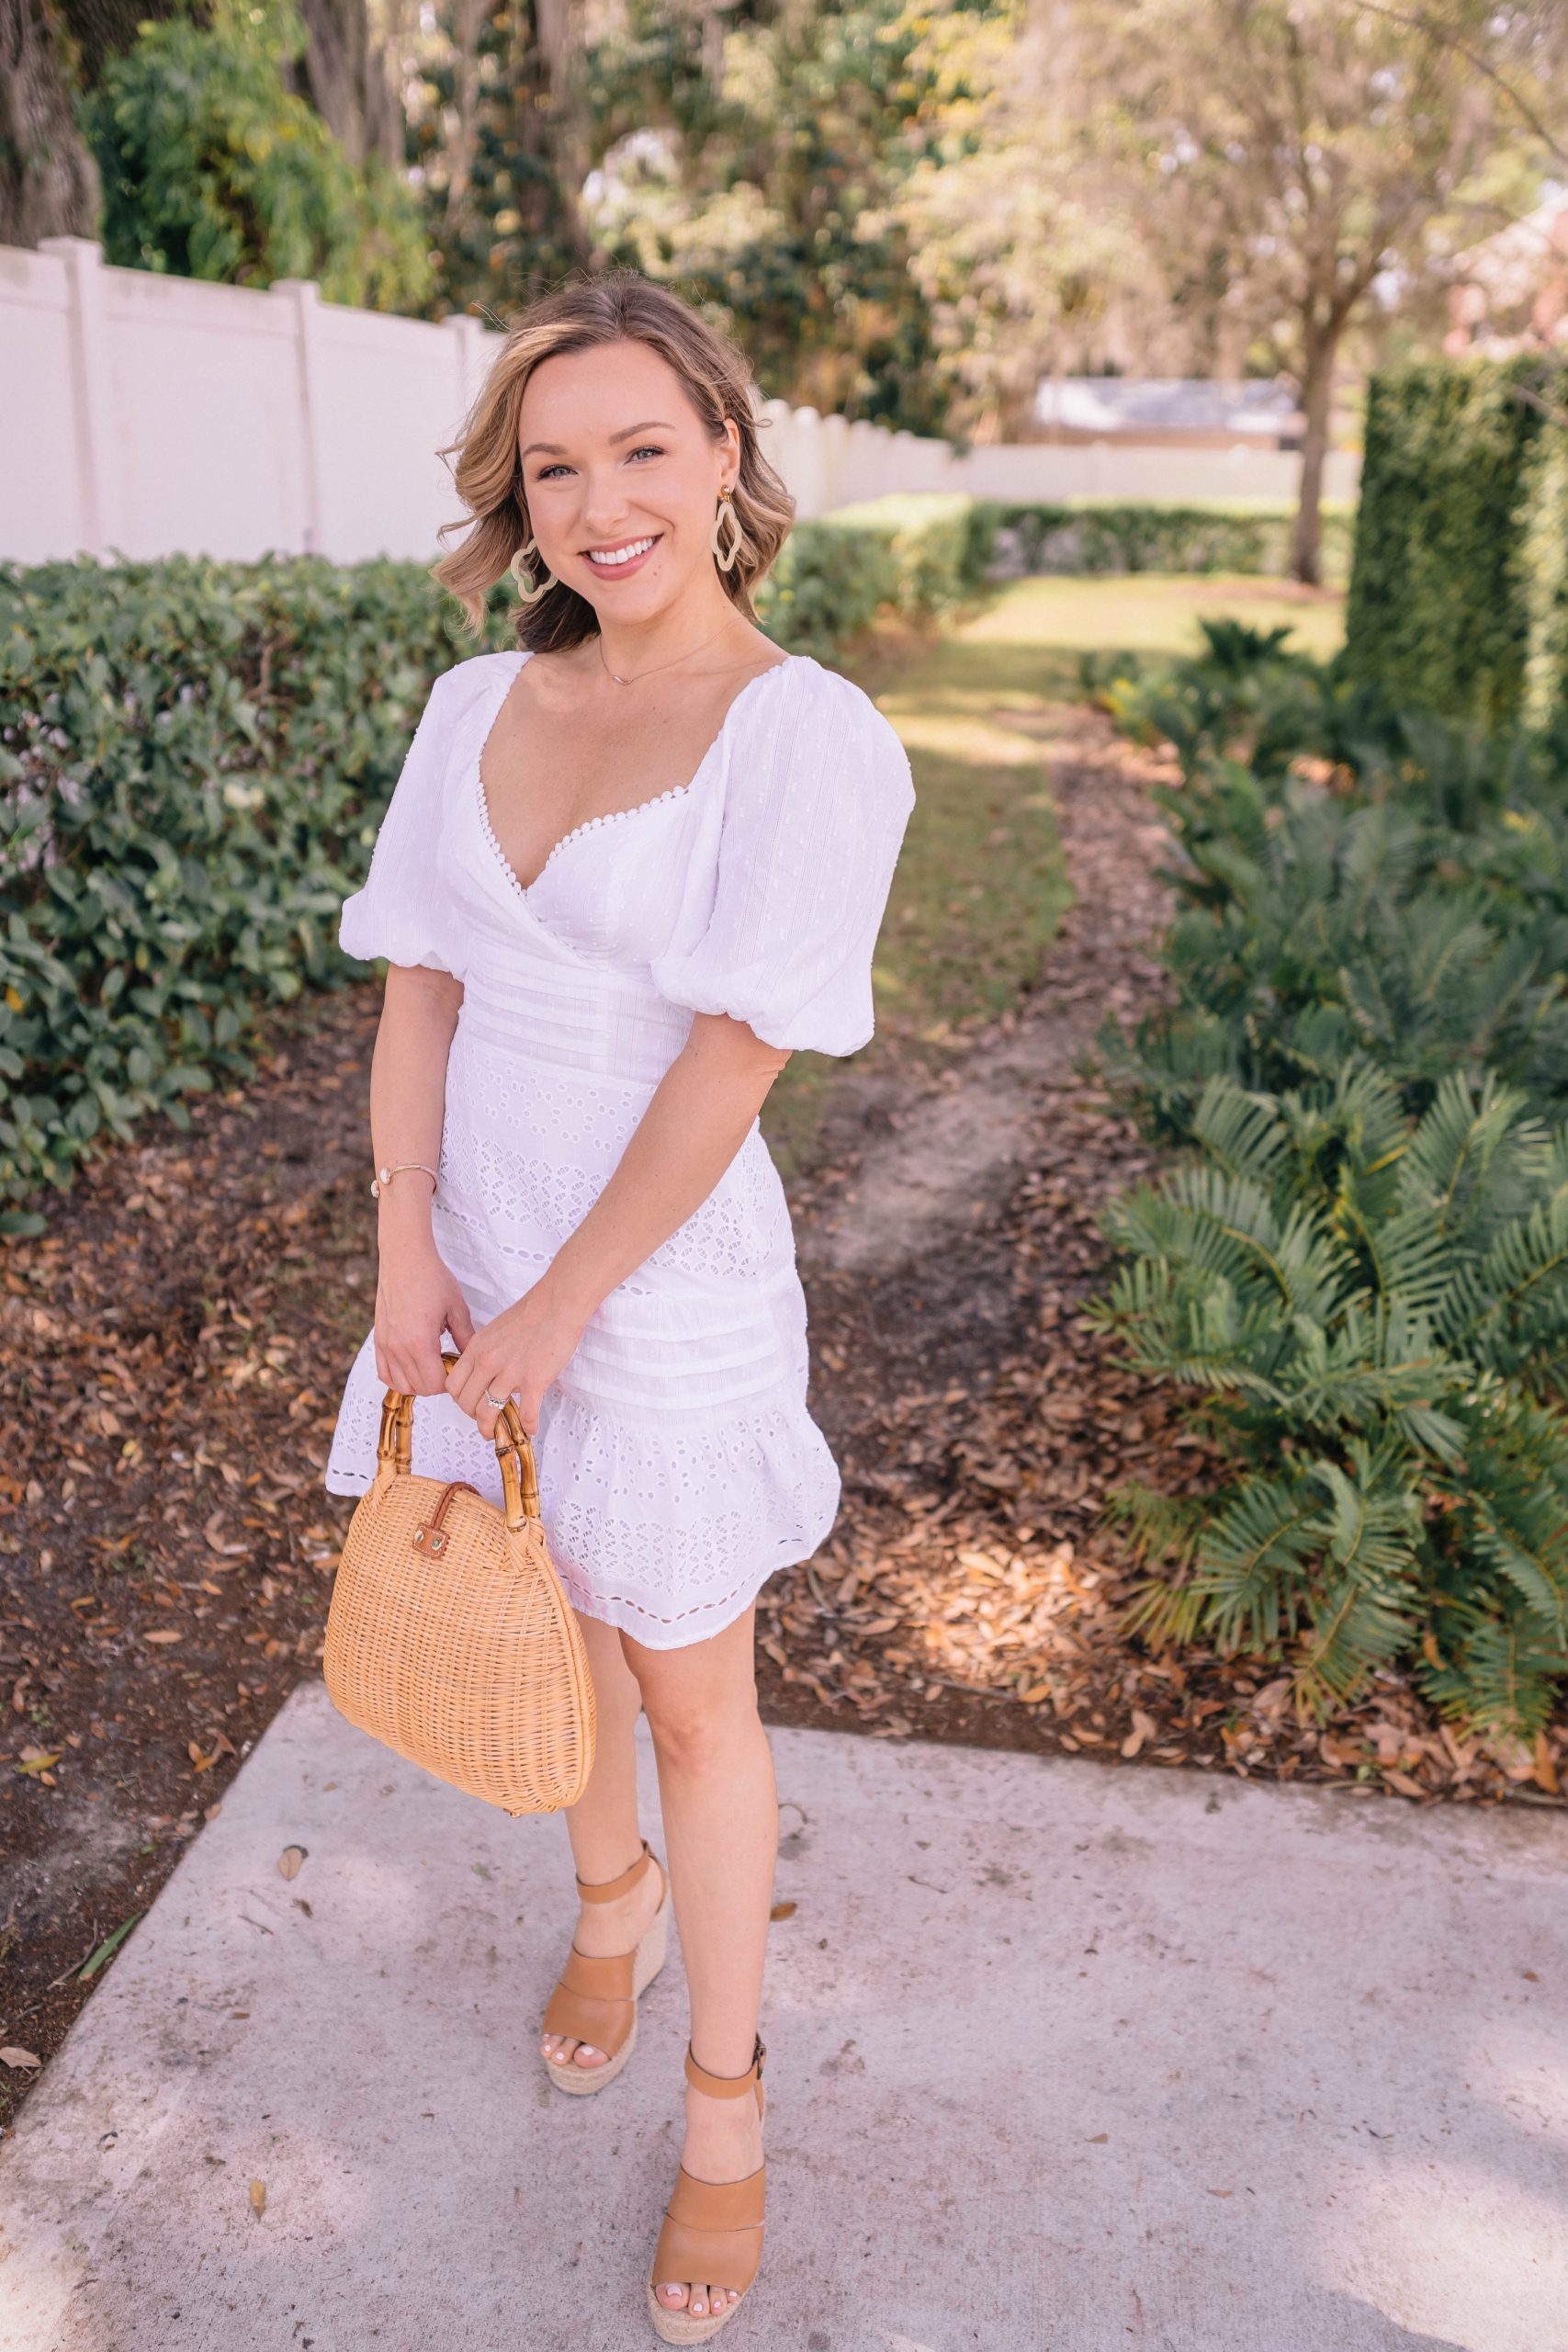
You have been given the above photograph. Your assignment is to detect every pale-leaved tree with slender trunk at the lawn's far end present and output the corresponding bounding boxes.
[1079,0,1542,581]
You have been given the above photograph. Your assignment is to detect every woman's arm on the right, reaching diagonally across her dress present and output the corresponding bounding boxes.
[446,1013,790,1437]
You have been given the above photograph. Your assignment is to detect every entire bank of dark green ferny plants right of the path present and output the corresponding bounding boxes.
[1093,626,1568,1734]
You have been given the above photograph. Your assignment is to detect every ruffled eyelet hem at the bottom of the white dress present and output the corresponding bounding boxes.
[324,1339,841,1649]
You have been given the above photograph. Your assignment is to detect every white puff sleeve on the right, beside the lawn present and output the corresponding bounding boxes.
[651,656,915,1054]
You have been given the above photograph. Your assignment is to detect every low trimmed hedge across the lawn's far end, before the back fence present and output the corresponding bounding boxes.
[980,499,1357,579]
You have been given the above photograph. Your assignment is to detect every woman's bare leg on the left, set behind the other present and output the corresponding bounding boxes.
[538,1616,663,2067]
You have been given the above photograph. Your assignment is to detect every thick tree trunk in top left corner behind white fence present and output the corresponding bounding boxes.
[0,0,101,247]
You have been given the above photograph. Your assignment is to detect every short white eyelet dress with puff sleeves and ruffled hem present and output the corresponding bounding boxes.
[324,654,915,1649]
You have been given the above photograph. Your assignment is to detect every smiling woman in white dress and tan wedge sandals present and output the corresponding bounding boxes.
[327,277,915,2343]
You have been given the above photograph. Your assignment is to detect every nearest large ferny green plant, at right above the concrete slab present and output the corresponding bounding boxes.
[1090,1077,1568,1736]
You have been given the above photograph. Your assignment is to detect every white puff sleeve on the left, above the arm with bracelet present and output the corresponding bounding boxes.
[339,663,466,978]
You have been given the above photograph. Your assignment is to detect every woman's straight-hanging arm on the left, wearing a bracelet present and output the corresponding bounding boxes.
[369,965,472,1397]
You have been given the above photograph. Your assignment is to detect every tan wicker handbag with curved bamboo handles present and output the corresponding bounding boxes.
[322,1357,594,1815]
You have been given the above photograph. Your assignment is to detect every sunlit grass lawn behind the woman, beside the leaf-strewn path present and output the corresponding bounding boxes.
[764,574,1345,1171]
